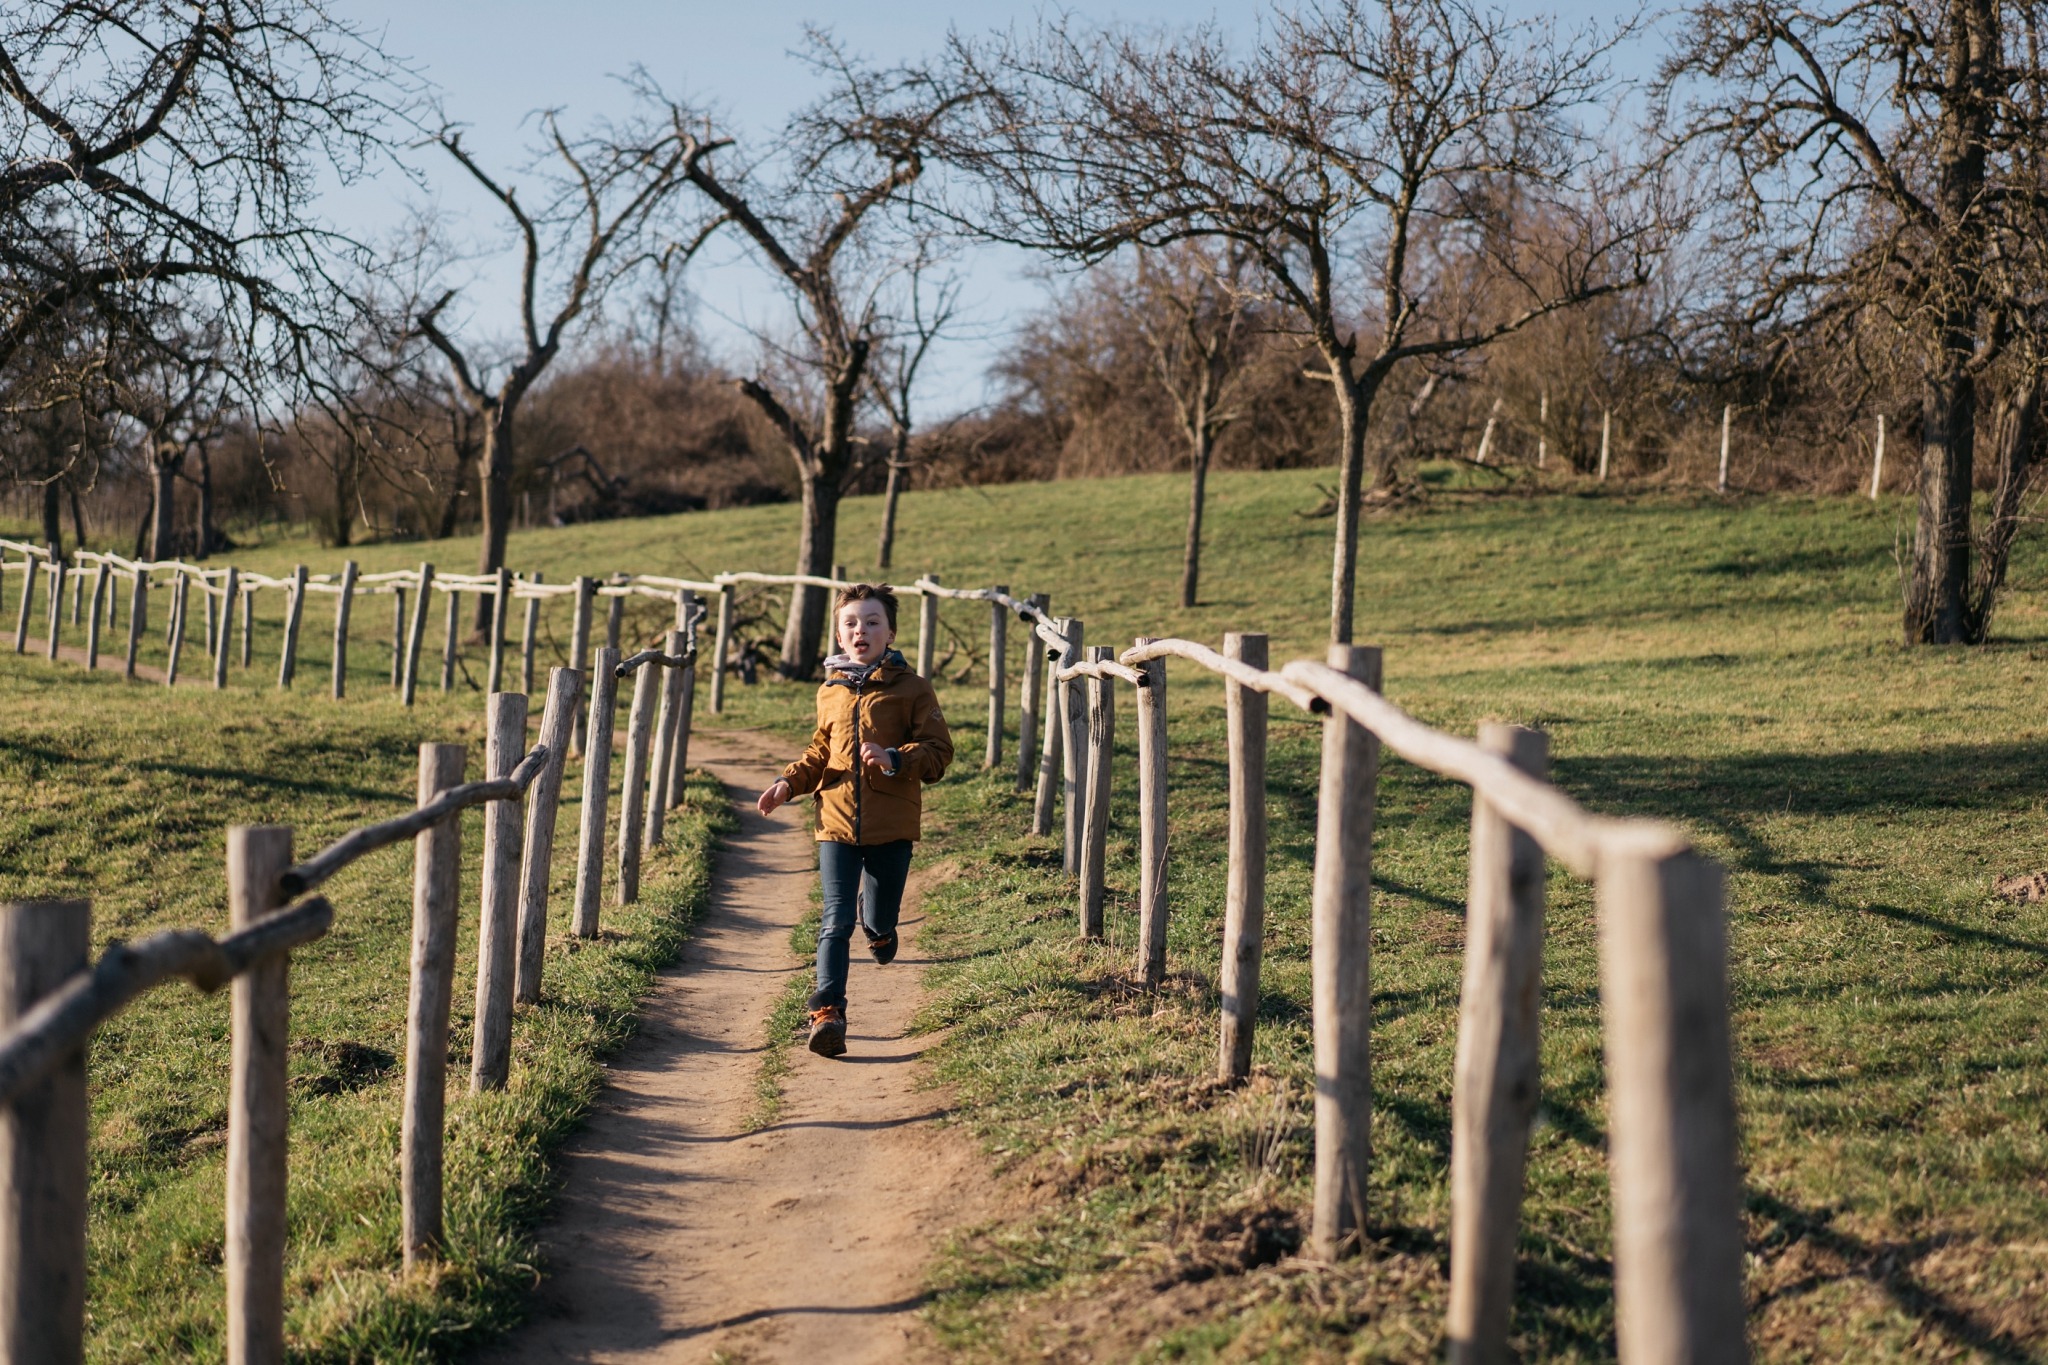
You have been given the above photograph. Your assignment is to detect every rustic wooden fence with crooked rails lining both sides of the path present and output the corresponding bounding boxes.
[0,556,1747,1363]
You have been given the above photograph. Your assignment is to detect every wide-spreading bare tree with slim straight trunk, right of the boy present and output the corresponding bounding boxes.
[944,0,1663,641]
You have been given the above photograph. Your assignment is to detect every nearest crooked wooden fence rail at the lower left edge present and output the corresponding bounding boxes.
[0,896,334,1109]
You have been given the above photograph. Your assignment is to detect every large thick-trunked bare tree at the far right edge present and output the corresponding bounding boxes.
[1661,0,2048,645]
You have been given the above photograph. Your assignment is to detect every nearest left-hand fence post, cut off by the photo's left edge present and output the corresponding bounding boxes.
[0,900,92,1365]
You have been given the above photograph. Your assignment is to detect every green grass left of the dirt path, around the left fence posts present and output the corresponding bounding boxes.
[0,655,729,1363]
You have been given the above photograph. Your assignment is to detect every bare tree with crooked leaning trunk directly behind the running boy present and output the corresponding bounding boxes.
[686,43,952,677]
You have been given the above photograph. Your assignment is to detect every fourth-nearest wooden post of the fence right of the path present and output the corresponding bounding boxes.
[1217,630,1266,1081]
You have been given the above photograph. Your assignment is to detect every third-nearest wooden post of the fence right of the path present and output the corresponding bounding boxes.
[1309,645,1380,1261]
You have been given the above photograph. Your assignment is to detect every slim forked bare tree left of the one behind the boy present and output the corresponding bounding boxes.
[416,97,719,630]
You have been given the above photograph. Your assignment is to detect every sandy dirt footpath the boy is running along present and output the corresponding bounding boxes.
[485,731,989,1365]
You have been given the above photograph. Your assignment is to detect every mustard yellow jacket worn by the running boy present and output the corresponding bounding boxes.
[782,651,952,843]
